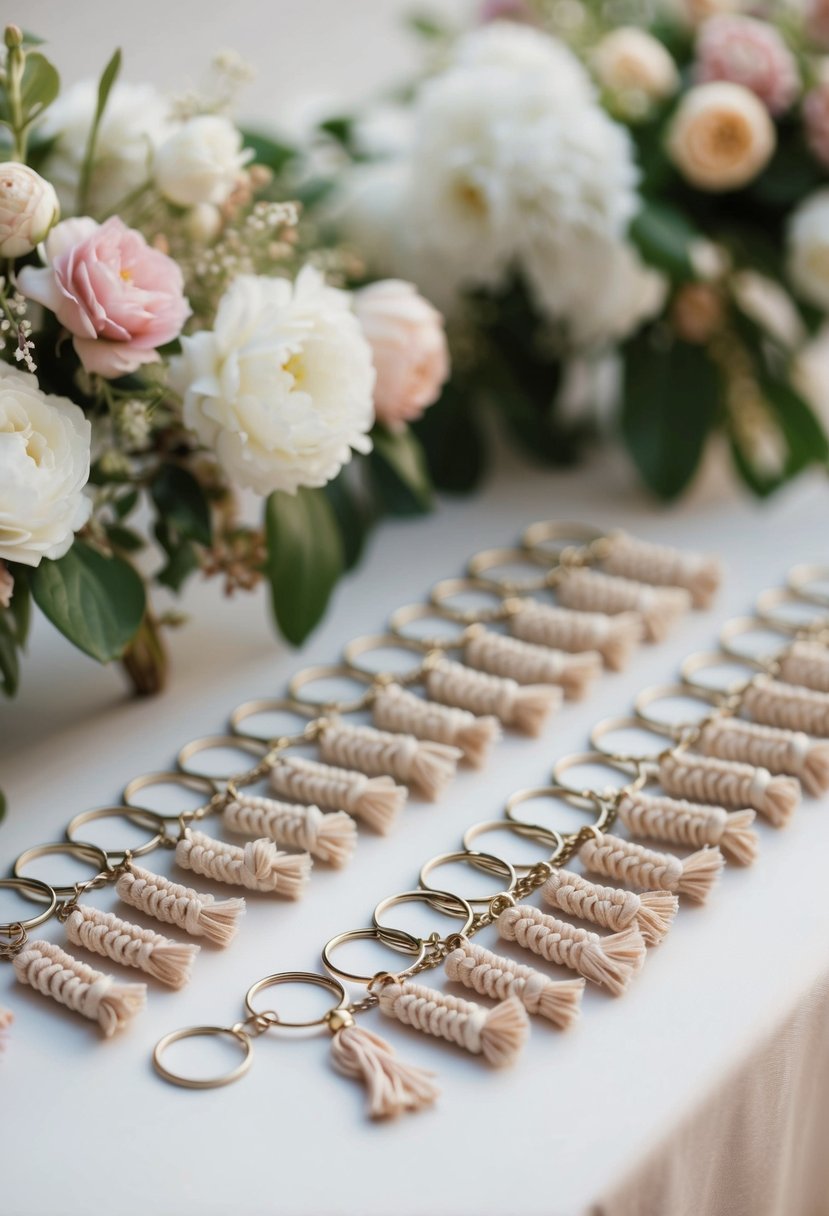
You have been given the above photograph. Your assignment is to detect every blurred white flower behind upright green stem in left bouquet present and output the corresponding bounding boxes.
[41,80,171,215]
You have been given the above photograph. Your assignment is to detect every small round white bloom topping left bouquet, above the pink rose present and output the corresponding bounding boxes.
[153,114,253,207]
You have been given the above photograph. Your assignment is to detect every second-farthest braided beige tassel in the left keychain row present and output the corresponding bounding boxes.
[556,569,690,642]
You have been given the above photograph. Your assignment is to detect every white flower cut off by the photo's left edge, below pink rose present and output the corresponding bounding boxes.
[0,364,92,565]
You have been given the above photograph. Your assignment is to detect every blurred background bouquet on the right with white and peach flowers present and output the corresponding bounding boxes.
[318,0,829,499]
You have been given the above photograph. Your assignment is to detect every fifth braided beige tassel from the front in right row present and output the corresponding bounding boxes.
[579,834,724,903]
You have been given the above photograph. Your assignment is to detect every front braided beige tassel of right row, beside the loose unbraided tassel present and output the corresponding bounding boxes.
[378,980,529,1068]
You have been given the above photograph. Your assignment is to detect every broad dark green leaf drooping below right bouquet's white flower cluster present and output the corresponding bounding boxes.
[621,330,720,499]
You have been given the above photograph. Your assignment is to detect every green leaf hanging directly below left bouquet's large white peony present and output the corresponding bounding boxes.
[265,489,345,646]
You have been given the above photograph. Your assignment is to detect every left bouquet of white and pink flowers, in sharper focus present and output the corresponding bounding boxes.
[0,26,449,719]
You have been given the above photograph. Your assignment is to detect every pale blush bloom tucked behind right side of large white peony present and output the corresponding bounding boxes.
[354,278,450,430]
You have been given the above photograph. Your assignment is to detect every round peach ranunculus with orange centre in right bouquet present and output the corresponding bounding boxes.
[667,80,777,191]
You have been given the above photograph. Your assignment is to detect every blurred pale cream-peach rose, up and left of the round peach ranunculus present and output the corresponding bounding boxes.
[592,26,679,117]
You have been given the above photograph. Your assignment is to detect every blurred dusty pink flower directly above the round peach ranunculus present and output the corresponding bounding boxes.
[697,13,800,114]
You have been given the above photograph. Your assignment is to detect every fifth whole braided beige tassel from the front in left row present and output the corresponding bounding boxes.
[221,794,357,869]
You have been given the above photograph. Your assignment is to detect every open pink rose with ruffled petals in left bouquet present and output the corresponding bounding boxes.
[18,215,190,379]
